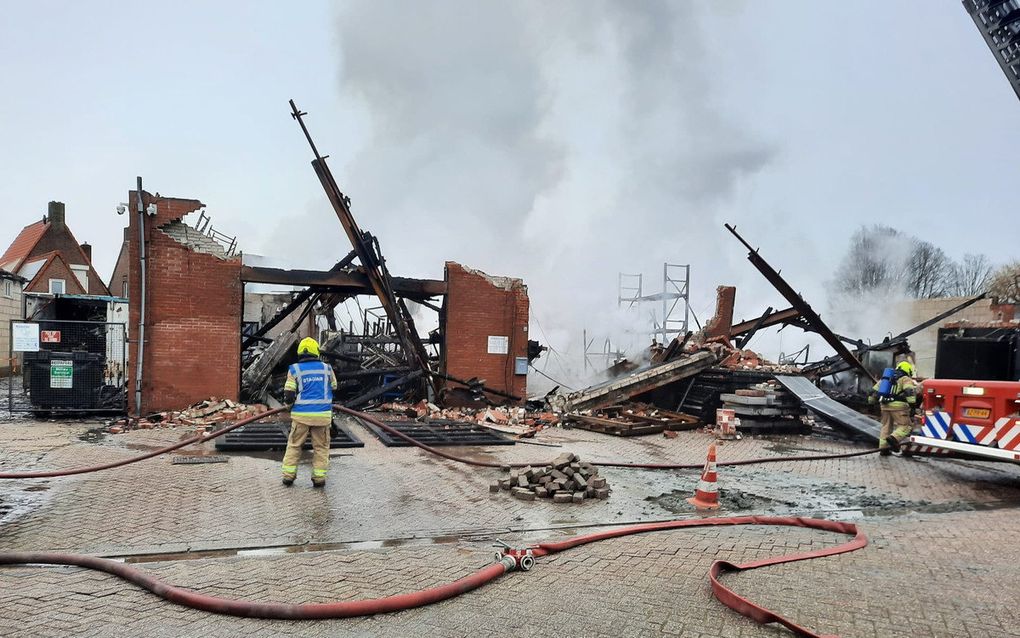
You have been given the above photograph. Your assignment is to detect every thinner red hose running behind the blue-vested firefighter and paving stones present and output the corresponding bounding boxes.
[0,404,878,480]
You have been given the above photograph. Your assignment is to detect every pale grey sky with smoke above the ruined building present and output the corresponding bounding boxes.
[0,0,1020,383]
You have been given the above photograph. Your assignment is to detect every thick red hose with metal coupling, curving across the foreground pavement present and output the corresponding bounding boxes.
[0,517,868,638]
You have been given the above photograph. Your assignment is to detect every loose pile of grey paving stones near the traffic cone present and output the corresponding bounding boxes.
[489,452,610,503]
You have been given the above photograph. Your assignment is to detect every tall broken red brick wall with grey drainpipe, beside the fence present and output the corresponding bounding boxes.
[128,192,242,412]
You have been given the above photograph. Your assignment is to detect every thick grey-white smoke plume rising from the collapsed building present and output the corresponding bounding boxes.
[314,1,773,383]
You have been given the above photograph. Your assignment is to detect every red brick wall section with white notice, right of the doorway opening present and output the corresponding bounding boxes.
[443,261,528,398]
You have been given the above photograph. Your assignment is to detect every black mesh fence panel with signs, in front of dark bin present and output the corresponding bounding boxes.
[7,320,128,412]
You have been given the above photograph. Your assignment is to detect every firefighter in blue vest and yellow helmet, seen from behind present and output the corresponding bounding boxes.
[283,337,337,487]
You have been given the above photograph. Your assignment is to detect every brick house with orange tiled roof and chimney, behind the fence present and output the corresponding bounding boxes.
[0,201,110,296]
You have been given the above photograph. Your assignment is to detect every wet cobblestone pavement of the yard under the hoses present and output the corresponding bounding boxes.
[0,421,1020,636]
